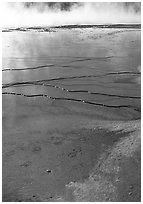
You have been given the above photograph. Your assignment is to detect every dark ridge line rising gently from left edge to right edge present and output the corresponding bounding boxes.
[2,71,141,88]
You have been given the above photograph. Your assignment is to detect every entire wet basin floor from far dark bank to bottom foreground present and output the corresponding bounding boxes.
[3,28,140,201]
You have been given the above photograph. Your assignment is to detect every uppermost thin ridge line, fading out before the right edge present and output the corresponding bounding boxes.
[2,56,114,72]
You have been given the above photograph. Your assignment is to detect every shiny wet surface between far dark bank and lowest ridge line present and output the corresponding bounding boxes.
[3,28,141,118]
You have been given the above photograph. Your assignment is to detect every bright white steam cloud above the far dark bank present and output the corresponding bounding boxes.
[2,2,141,28]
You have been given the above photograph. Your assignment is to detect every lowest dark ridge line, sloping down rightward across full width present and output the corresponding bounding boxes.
[2,92,141,112]
